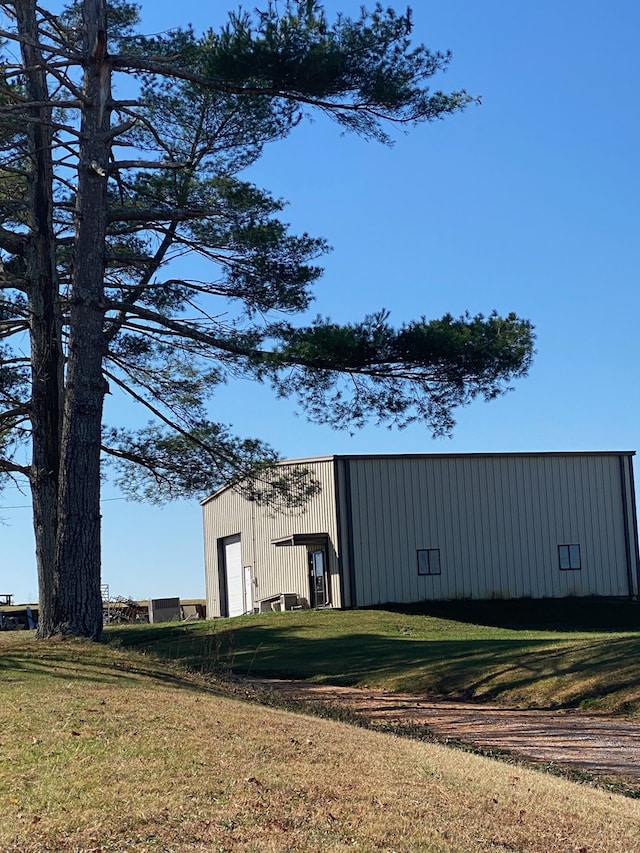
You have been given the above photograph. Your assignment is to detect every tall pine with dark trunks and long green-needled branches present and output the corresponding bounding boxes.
[0,0,532,639]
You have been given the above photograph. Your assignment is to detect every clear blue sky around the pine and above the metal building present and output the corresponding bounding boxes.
[0,0,640,600]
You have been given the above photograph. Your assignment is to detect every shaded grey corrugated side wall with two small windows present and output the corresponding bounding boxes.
[338,454,637,606]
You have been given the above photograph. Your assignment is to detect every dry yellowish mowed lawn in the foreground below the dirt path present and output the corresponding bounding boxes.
[0,628,640,853]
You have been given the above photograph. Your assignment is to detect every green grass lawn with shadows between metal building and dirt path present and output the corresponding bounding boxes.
[108,600,640,716]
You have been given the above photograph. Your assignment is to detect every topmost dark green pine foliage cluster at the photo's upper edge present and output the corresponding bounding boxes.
[166,0,471,142]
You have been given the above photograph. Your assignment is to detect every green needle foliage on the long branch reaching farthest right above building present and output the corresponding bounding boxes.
[256,311,533,435]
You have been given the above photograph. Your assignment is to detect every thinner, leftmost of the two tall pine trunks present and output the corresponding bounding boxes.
[15,0,63,636]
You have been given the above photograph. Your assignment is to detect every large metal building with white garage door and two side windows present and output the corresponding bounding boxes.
[202,451,640,616]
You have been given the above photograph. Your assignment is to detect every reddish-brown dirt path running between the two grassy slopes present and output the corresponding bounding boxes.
[239,679,640,793]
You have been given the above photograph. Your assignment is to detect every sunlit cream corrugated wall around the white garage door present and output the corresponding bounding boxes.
[203,458,342,616]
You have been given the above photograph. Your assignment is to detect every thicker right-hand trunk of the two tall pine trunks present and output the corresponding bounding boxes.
[56,0,111,639]
